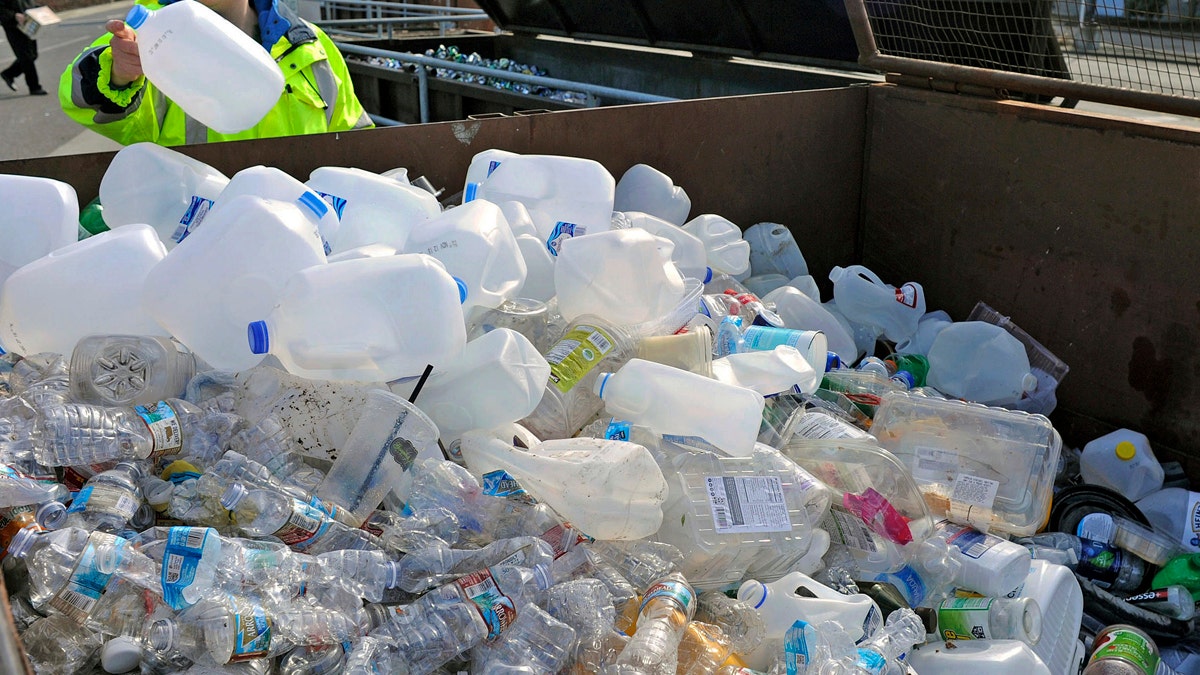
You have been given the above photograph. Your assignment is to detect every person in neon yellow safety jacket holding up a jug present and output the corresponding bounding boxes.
[59,0,374,145]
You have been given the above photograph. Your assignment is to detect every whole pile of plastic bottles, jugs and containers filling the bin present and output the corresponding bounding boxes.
[0,139,1200,675]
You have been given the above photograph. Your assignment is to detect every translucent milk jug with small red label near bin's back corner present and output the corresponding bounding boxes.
[829,265,925,342]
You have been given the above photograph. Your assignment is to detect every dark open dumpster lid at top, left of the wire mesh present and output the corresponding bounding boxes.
[475,0,858,62]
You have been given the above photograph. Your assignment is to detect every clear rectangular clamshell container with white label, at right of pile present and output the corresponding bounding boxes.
[871,392,1062,536]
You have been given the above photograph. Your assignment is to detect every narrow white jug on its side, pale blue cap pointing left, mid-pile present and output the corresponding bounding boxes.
[592,354,763,456]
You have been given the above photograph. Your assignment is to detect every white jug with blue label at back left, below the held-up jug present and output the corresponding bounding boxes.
[100,142,229,250]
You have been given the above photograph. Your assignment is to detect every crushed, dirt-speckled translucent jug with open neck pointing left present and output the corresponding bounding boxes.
[461,432,667,539]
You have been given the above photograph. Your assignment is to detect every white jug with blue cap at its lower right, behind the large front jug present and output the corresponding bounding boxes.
[404,199,526,315]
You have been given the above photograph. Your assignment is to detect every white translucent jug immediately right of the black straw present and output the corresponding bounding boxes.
[403,328,550,444]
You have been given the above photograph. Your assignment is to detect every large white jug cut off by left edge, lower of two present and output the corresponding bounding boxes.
[0,225,167,357]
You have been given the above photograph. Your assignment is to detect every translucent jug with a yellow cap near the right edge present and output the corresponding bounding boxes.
[1080,425,1164,501]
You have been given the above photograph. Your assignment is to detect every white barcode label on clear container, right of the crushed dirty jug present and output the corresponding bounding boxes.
[704,476,792,534]
